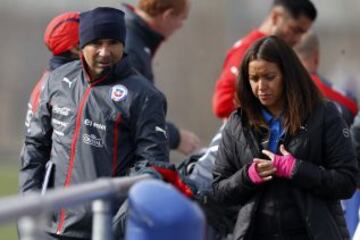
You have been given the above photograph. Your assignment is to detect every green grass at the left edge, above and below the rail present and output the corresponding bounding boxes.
[0,161,18,240]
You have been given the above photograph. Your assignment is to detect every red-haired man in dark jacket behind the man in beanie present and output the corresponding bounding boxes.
[123,0,200,155]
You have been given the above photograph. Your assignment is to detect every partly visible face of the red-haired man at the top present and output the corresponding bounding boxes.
[163,0,190,37]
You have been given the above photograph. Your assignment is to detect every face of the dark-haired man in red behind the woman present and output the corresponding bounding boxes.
[273,13,312,46]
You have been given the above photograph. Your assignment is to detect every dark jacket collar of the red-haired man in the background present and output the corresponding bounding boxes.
[123,4,165,57]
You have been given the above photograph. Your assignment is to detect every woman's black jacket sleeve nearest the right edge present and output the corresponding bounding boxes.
[292,103,357,199]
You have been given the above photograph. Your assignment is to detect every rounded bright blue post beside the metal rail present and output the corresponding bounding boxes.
[126,180,205,240]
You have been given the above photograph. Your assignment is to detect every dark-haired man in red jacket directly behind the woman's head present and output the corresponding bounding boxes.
[212,0,317,119]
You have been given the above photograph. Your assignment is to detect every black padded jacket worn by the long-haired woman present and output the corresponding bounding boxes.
[213,101,357,240]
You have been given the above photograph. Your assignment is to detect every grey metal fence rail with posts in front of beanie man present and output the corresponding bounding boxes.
[0,174,151,240]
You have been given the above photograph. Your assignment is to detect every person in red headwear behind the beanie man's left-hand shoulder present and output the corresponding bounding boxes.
[25,12,80,127]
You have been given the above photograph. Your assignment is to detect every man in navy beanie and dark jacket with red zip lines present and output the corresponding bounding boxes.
[20,8,168,239]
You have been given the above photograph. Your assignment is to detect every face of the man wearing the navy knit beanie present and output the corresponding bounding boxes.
[82,39,124,80]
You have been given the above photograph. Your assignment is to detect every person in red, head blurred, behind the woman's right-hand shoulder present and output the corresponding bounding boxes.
[294,31,358,126]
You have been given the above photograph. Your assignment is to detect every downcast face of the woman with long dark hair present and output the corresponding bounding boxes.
[249,59,284,116]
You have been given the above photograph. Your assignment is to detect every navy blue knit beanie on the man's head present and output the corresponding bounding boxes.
[79,7,126,48]
